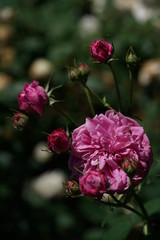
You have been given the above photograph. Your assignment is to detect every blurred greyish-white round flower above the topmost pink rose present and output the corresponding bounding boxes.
[78,14,100,38]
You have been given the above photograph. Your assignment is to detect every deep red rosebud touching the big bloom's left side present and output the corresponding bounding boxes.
[48,128,70,153]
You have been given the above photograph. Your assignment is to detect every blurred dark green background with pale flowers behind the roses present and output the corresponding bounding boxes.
[0,0,160,240]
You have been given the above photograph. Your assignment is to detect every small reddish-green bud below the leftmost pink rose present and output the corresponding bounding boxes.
[12,112,29,130]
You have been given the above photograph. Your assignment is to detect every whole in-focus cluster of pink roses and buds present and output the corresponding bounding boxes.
[13,40,153,201]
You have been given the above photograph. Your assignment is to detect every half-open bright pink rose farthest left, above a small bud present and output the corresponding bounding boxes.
[18,80,48,115]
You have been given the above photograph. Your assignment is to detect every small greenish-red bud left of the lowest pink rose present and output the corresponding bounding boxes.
[64,180,80,197]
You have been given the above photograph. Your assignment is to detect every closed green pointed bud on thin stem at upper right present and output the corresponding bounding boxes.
[126,47,139,68]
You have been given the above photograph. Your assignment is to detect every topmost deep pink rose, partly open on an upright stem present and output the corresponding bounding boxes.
[90,40,113,63]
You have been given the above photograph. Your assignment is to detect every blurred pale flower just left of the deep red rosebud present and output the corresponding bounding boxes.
[33,142,52,163]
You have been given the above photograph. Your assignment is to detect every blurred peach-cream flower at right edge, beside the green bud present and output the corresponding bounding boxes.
[138,58,160,87]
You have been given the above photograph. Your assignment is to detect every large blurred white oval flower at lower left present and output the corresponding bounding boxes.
[25,170,66,198]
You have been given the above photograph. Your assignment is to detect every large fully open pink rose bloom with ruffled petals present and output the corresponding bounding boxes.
[69,110,152,193]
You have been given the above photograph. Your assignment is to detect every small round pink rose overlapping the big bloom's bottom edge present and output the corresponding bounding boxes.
[79,170,107,197]
